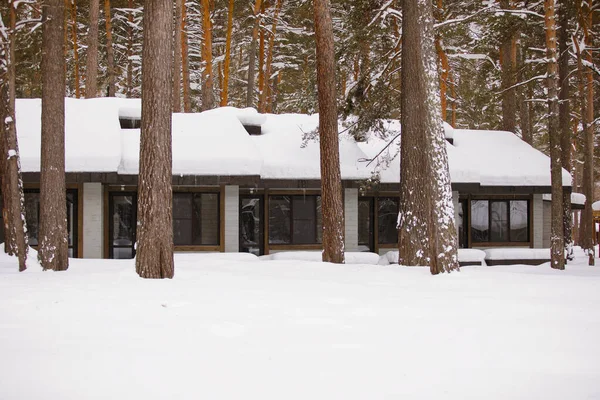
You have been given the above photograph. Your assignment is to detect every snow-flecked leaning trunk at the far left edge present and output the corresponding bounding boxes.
[0,0,28,271]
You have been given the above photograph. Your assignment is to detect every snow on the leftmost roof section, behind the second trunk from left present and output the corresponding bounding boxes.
[16,98,121,172]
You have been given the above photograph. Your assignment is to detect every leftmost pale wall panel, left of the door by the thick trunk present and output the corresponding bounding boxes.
[82,183,104,258]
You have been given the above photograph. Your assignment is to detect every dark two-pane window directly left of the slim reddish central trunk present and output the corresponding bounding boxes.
[269,195,323,244]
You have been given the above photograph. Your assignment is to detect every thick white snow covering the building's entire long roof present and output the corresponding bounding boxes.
[12,98,571,186]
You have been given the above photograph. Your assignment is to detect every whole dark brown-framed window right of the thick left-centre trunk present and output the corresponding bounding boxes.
[173,193,219,246]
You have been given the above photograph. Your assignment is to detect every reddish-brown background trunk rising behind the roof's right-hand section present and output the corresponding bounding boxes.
[500,0,517,132]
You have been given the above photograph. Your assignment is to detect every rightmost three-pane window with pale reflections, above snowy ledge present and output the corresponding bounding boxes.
[471,200,529,243]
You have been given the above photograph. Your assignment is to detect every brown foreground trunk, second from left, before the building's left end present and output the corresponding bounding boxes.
[38,0,69,271]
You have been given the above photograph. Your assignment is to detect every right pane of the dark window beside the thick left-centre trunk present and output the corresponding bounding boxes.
[193,193,219,246]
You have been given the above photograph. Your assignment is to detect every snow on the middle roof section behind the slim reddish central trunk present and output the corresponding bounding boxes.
[251,114,370,179]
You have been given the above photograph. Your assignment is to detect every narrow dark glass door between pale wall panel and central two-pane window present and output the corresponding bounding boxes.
[240,195,265,256]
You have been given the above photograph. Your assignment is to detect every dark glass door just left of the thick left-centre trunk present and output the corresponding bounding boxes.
[108,192,137,258]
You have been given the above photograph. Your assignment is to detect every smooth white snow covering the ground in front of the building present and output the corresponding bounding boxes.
[0,248,600,400]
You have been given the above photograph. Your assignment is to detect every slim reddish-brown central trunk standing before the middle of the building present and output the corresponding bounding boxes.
[313,0,344,263]
